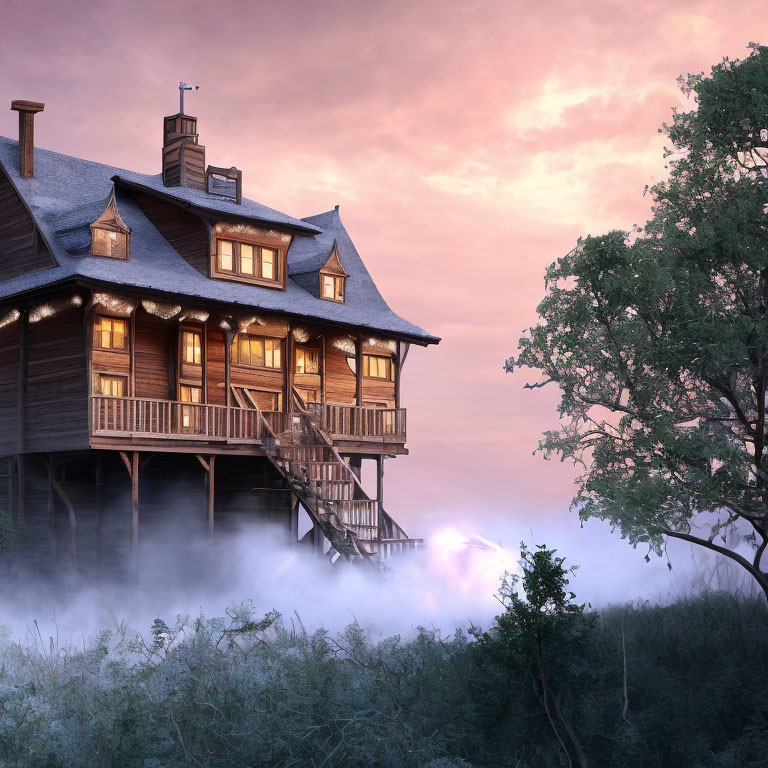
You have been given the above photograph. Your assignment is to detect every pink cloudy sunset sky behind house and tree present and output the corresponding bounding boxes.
[0,0,765,600]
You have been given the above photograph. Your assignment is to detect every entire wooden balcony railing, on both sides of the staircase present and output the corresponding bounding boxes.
[91,395,405,442]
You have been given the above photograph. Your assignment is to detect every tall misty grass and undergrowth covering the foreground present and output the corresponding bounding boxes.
[0,594,768,768]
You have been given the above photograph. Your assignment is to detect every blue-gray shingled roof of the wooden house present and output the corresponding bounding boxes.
[0,137,439,343]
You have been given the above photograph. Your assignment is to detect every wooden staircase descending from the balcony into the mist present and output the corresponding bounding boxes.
[259,393,424,563]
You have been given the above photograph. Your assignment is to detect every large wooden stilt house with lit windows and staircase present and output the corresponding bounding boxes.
[0,101,439,573]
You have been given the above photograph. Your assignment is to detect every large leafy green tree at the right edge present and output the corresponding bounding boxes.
[506,44,768,597]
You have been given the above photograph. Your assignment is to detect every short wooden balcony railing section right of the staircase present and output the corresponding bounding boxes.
[307,403,406,443]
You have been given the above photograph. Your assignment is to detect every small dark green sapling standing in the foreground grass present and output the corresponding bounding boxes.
[474,543,596,768]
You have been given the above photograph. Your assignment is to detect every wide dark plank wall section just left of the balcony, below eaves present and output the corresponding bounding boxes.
[24,307,88,452]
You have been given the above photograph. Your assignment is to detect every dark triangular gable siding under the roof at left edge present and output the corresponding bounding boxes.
[0,169,56,280]
